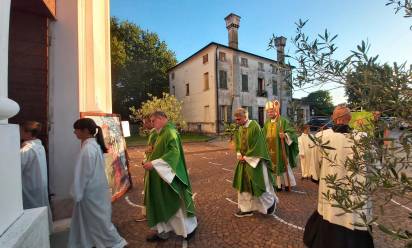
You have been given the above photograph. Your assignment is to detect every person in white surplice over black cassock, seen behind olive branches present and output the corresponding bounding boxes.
[304,106,374,248]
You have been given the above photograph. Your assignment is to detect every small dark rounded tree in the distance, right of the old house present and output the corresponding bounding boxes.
[302,90,333,116]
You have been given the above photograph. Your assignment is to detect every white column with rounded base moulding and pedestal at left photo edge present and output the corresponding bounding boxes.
[0,0,23,236]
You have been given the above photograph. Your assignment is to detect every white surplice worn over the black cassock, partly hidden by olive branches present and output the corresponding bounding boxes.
[317,129,371,230]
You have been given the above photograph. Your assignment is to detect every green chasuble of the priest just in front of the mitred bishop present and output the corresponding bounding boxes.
[233,120,273,197]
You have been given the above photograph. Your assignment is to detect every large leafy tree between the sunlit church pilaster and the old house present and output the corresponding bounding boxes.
[110,17,176,119]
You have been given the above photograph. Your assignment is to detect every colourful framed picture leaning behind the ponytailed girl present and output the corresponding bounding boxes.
[80,112,132,201]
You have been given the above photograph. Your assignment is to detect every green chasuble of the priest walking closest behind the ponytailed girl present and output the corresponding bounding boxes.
[144,123,195,227]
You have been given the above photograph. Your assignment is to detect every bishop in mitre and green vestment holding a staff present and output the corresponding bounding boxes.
[263,101,299,191]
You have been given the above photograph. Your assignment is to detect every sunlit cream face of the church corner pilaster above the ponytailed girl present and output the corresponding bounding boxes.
[78,0,112,113]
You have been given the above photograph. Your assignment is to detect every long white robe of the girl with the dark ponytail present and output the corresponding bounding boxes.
[68,138,127,248]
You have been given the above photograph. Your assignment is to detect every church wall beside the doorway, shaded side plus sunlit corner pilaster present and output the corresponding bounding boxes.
[49,0,112,201]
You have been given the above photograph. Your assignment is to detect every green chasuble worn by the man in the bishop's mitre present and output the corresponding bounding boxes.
[263,116,299,175]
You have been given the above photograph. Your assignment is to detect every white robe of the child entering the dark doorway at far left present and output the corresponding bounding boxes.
[20,139,53,231]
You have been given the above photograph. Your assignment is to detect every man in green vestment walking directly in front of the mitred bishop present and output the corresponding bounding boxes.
[233,108,278,217]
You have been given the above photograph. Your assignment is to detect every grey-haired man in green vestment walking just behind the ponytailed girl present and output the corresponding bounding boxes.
[143,111,197,242]
